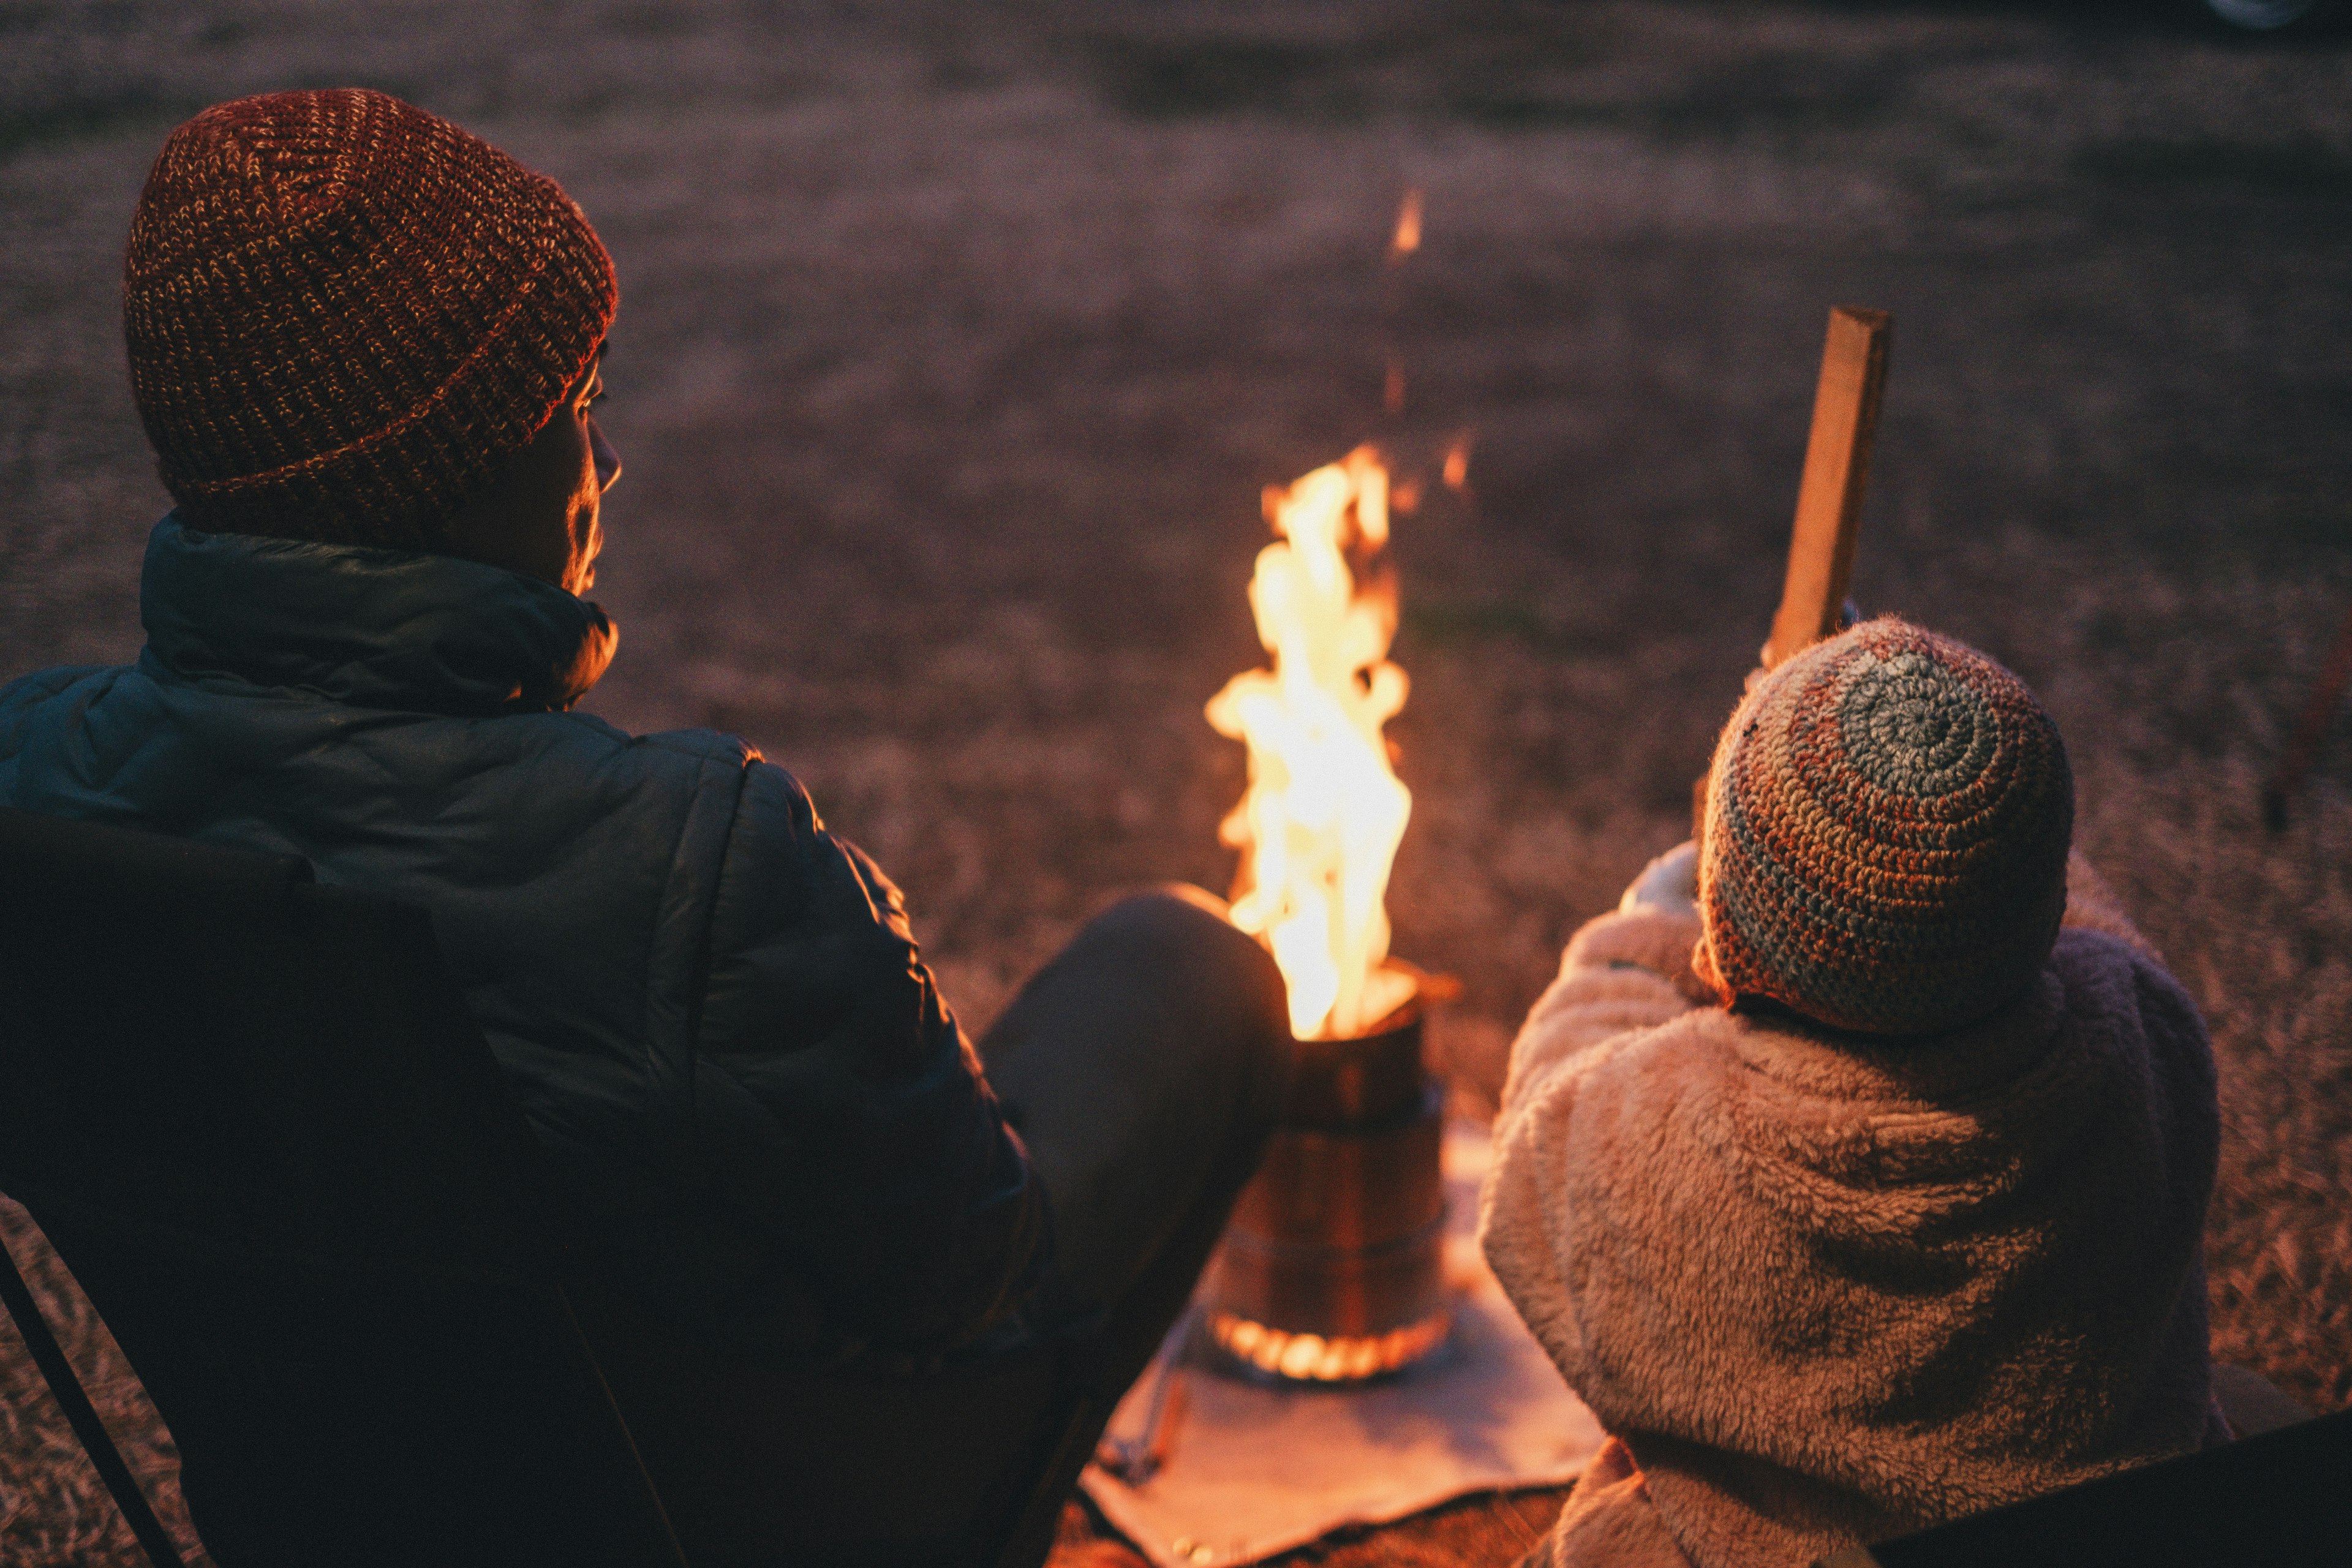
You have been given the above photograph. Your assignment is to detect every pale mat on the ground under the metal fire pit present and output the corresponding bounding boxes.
[1084,1121,1602,1568]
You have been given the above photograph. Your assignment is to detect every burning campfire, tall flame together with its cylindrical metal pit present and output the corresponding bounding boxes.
[1209,447,1451,1382]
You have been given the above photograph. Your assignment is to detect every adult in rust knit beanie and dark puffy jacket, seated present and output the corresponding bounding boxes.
[0,89,1289,1561]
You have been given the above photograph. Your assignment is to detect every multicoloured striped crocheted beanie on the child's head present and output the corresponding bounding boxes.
[1696,618,2075,1035]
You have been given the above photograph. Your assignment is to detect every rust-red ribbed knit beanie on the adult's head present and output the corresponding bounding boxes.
[123,87,619,550]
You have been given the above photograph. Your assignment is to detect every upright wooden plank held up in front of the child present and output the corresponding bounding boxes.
[1764,306,1893,670]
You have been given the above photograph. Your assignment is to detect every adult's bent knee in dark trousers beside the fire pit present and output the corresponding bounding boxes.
[981,889,1291,1385]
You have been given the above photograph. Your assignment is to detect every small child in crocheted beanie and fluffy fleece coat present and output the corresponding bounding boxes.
[1479,618,2227,1568]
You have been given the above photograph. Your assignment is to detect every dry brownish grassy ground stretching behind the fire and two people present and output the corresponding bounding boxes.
[0,0,2352,1563]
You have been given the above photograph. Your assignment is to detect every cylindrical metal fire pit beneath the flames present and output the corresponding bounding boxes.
[1209,995,1453,1382]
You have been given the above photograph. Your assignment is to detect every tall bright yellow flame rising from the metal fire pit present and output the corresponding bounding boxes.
[1209,447,1414,1039]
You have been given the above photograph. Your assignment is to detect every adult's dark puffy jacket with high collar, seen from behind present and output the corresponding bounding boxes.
[0,517,1047,1354]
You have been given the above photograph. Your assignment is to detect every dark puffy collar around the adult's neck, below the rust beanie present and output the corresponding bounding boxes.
[139,513,619,715]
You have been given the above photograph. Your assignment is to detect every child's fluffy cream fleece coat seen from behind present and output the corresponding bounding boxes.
[1479,861,2225,1568]
